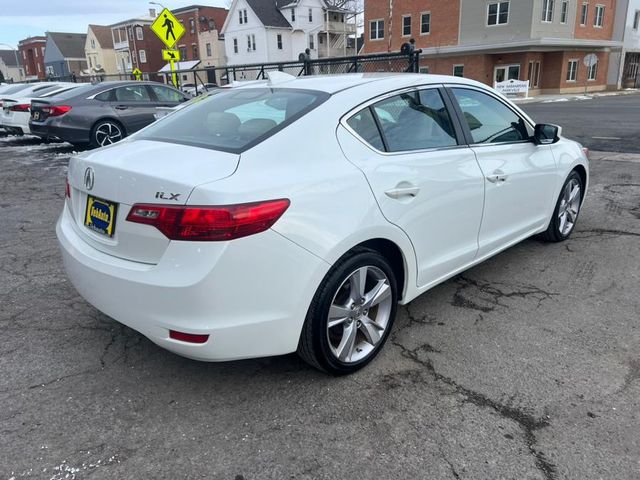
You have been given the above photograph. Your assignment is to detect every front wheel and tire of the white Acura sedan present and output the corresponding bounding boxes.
[541,170,584,242]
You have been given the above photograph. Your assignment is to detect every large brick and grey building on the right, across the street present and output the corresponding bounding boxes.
[364,0,620,94]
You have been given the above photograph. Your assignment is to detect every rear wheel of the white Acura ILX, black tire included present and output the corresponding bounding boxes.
[298,249,398,375]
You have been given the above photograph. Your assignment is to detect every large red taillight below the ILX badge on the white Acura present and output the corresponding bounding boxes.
[127,199,290,241]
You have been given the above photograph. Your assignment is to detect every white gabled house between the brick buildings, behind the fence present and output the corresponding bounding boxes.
[222,0,356,65]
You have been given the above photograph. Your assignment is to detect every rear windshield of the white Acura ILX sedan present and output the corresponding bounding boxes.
[135,88,329,153]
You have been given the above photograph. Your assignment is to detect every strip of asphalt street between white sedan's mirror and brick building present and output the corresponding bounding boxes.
[520,92,640,153]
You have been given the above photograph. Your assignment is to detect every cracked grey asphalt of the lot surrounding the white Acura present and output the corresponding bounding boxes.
[0,137,640,480]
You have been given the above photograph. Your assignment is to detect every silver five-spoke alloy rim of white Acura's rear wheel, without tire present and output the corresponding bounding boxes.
[327,266,393,363]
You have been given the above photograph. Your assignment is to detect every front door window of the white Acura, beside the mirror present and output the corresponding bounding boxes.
[452,88,533,143]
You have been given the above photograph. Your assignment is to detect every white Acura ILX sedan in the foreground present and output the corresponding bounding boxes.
[57,73,588,374]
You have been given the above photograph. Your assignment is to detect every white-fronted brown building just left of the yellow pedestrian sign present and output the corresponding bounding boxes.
[111,10,166,79]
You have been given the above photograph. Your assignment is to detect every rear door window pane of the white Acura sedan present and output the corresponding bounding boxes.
[373,90,458,152]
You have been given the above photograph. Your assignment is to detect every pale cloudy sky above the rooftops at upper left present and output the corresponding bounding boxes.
[0,0,230,49]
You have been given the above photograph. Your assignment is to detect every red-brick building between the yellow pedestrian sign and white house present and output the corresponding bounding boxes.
[171,5,229,67]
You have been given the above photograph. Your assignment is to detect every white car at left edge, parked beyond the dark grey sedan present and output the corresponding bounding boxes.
[0,82,81,135]
